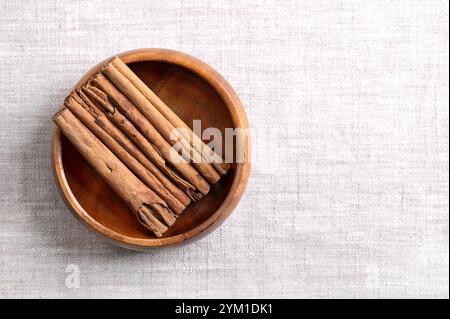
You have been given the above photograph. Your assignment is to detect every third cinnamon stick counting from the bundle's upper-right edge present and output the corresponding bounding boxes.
[90,73,209,200]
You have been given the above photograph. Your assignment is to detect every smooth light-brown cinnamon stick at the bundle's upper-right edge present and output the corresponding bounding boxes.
[111,57,230,175]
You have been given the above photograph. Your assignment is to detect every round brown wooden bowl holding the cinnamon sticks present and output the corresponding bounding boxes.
[52,49,250,250]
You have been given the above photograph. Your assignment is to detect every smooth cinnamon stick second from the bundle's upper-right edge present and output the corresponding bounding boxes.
[102,63,220,183]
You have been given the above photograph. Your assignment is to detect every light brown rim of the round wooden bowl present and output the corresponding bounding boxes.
[51,48,250,250]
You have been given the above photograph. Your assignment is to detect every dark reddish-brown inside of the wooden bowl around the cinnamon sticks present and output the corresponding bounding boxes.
[61,61,236,239]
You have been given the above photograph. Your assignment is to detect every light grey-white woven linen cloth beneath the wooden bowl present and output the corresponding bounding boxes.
[0,0,449,298]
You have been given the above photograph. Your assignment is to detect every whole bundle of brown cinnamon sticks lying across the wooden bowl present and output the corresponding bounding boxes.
[53,57,230,237]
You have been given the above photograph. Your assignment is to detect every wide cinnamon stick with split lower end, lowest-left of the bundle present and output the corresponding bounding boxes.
[53,108,175,237]
